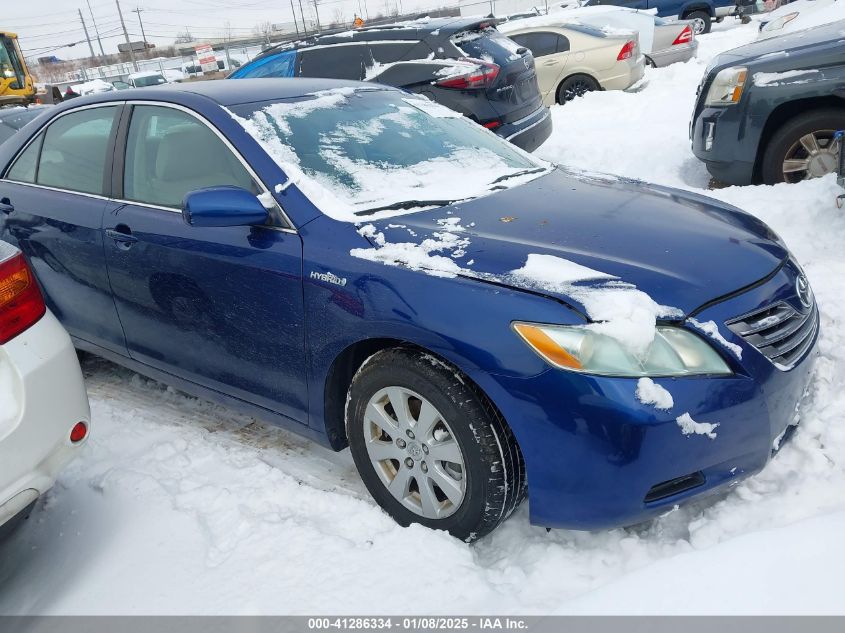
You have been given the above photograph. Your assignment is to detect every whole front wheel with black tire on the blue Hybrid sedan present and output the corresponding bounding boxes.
[346,348,525,542]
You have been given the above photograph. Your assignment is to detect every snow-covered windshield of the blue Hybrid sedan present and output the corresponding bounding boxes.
[232,88,547,221]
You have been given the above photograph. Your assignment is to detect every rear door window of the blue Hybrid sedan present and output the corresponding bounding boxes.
[37,106,117,195]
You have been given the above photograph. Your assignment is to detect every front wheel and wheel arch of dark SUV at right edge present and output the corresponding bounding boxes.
[760,108,845,185]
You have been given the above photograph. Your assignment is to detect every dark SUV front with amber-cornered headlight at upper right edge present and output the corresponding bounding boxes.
[690,21,845,185]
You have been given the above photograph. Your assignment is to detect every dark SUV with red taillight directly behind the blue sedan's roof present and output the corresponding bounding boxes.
[229,18,552,151]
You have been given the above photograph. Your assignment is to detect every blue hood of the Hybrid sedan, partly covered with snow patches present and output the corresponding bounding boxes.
[361,169,789,314]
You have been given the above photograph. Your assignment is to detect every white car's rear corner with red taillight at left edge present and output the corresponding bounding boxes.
[0,241,91,532]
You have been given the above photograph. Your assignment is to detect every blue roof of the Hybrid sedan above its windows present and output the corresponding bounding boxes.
[52,78,380,107]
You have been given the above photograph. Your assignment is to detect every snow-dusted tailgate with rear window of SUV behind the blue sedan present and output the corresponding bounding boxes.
[451,27,542,123]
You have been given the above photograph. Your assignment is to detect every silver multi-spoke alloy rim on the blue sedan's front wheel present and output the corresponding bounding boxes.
[364,387,467,519]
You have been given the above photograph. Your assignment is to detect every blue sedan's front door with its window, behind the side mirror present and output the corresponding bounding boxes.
[104,104,307,423]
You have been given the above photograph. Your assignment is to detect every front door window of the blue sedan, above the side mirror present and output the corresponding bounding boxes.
[123,106,260,208]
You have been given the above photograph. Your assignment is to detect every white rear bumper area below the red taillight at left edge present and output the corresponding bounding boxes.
[0,311,91,525]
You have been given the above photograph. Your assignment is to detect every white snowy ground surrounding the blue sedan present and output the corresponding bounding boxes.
[0,24,845,614]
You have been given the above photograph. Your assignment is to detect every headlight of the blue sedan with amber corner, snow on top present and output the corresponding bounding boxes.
[513,322,733,377]
